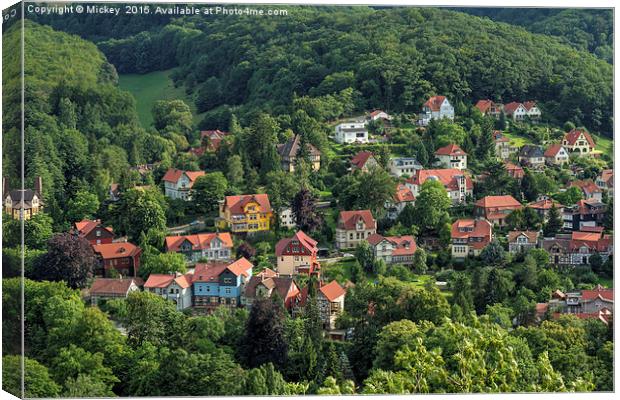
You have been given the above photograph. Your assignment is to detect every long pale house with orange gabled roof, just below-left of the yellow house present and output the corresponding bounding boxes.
[165,232,233,263]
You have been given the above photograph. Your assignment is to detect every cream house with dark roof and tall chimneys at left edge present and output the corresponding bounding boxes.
[2,176,43,220]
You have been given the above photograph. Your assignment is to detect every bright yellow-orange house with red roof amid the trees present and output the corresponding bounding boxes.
[217,194,273,233]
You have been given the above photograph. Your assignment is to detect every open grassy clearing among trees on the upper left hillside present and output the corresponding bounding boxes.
[118,69,197,128]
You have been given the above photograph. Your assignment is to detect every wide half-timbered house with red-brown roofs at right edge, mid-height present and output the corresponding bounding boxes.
[542,231,613,266]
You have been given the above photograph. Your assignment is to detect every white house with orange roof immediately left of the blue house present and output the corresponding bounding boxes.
[144,272,192,311]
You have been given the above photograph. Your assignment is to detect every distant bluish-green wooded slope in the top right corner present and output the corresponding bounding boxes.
[460,8,614,63]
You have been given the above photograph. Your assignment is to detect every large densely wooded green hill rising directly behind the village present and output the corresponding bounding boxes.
[94,8,612,133]
